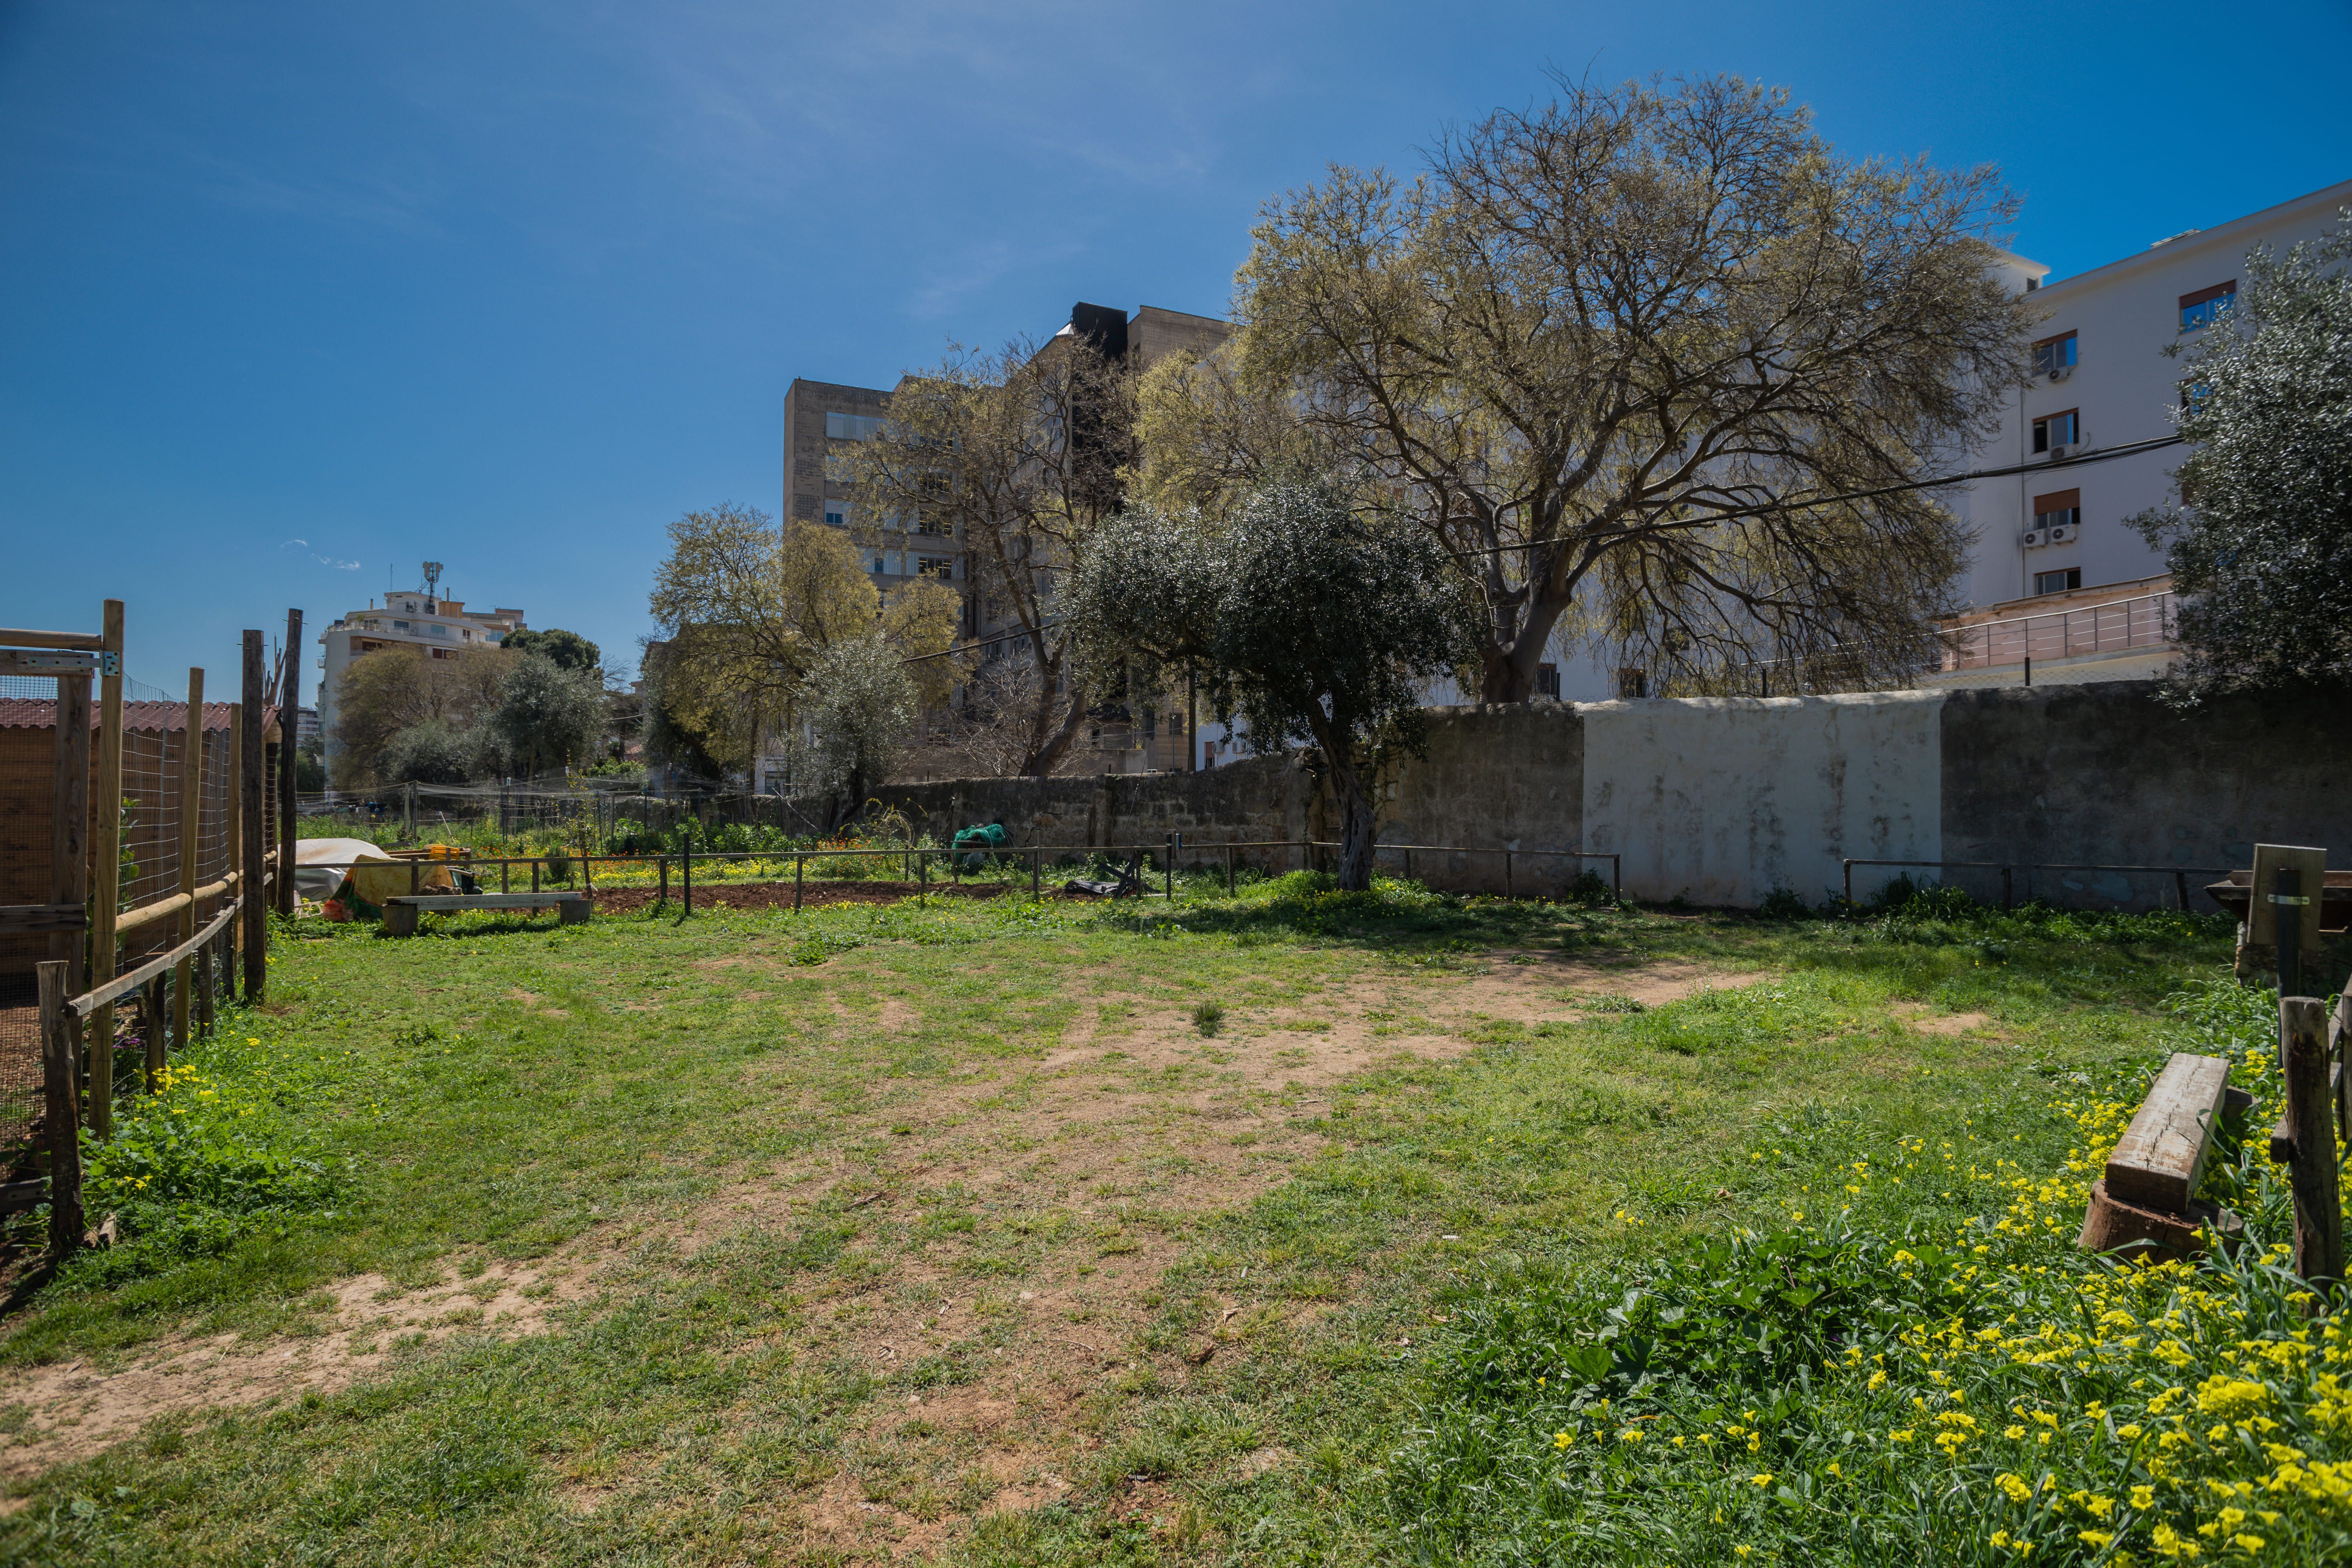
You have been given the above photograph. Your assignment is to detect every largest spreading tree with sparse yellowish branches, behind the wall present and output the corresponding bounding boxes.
[1138,78,2027,701]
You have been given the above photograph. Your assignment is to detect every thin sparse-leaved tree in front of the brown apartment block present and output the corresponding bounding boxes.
[837,332,1134,778]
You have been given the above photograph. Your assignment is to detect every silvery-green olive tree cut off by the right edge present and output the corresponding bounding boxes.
[2131,209,2352,701]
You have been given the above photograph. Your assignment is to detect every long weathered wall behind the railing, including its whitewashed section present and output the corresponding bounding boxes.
[851,682,2352,907]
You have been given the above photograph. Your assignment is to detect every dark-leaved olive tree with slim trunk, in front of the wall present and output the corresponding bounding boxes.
[1063,477,1475,891]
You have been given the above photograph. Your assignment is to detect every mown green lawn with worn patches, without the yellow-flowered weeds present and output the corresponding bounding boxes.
[0,877,2286,1563]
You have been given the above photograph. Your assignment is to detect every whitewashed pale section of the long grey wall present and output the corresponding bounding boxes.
[1583,691,1943,907]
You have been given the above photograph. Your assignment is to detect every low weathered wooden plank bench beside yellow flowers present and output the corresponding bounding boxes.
[2079,1051,2253,1255]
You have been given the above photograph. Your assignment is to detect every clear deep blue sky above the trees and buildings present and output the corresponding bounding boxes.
[0,0,2352,701]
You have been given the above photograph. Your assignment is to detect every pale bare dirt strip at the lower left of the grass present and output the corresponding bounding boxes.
[0,1262,588,1509]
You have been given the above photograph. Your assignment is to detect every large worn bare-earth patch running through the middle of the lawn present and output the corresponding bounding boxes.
[677,954,1762,1558]
